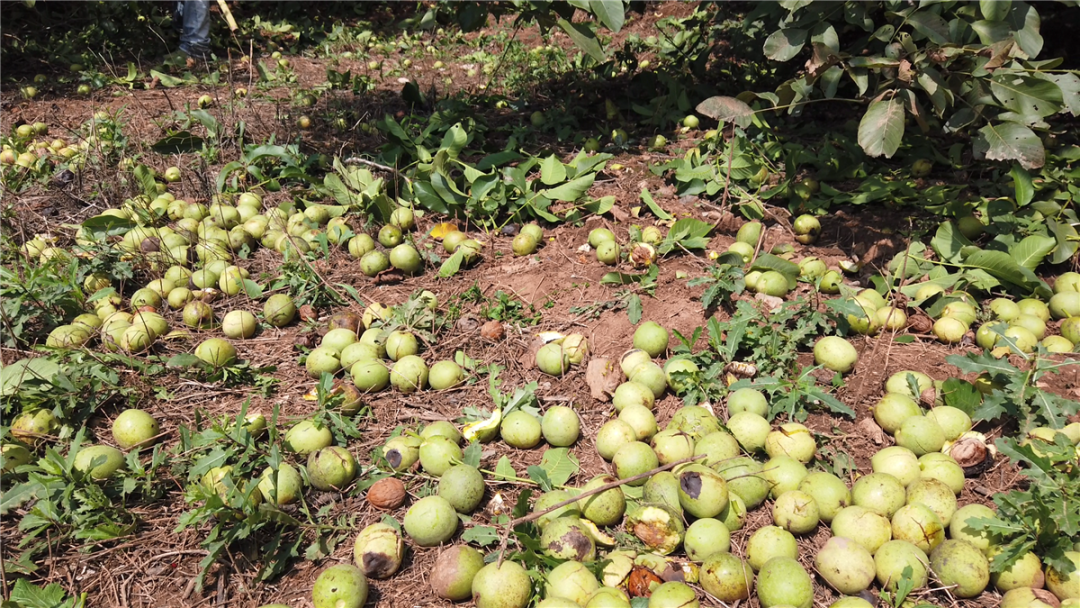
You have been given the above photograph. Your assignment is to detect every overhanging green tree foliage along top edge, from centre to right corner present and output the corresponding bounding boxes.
[456,0,1080,170]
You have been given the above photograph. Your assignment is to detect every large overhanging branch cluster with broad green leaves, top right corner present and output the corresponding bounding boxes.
[744,0,1080,170]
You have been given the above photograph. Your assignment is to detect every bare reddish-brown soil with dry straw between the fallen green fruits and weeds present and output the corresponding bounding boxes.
[0,3,1080,608]
